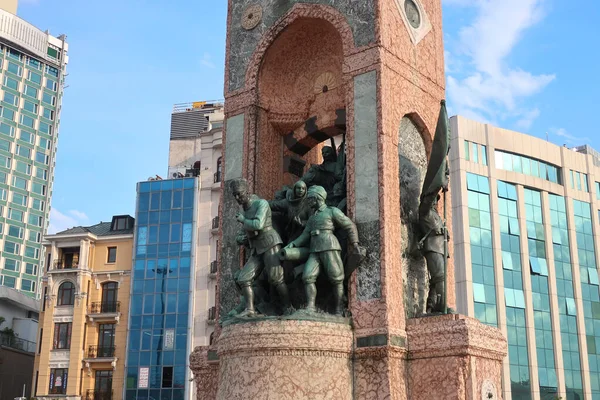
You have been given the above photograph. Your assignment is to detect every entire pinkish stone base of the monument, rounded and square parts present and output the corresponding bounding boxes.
[190,315,506,400]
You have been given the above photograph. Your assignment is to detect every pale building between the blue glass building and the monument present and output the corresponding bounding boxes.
[169,101,224,348]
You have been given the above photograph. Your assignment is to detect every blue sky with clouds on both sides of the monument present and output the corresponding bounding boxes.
[18,0,600,231]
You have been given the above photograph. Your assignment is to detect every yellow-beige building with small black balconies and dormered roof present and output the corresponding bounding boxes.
[33,215,134,400]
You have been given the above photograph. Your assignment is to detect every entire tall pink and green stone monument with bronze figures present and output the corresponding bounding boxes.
[190,0,506,400]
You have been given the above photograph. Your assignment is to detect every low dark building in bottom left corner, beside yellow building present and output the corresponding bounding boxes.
[0,286,40,399]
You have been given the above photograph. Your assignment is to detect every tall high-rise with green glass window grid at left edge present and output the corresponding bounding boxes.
[0,7,68,297]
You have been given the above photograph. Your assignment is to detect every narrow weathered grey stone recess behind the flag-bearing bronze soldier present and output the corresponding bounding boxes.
[398,117,429,318]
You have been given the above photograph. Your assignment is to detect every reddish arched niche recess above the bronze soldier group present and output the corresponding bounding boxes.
[251,18,346,198]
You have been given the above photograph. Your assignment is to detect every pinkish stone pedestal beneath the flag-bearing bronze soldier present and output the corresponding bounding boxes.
[406,315,507,400]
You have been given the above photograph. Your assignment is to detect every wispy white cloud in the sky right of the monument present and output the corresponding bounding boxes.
[445,0,555,128]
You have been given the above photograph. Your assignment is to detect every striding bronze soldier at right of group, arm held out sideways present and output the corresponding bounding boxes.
[286,186,361,315]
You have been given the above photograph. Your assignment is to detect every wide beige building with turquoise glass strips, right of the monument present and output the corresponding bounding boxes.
[450,117,600,400]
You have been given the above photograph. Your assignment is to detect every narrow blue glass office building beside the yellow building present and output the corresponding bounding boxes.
[124,178,199,400]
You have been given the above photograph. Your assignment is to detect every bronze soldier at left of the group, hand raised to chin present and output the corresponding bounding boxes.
[231,179,290,317]
